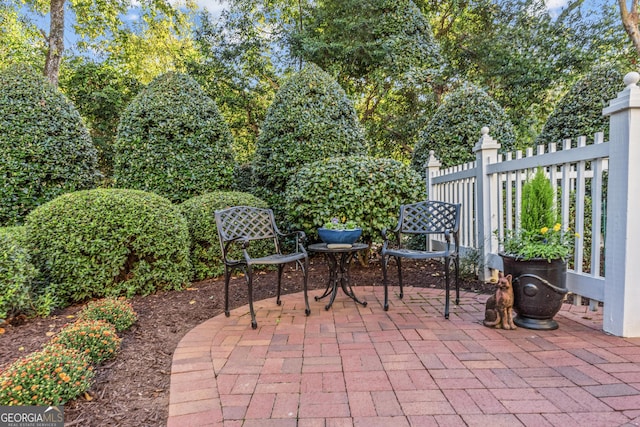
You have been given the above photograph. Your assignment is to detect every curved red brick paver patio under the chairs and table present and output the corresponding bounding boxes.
[168,286,640,427]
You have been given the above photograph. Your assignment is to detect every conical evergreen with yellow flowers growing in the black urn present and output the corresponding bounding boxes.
[502,168,580,261]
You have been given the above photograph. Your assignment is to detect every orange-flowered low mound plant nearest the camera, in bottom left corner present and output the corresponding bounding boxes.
[0,344,94,406]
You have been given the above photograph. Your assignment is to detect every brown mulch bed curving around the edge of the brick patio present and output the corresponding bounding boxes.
[0,256,492,427]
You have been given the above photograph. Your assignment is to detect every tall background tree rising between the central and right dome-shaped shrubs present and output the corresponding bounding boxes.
[291,0,443,160]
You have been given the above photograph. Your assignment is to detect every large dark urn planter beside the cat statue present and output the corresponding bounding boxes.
[500,254,568,330]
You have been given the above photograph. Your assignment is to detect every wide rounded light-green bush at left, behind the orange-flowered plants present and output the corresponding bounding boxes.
[25,189,190,303]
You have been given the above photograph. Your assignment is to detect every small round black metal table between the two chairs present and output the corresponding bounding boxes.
[307,243,369,310]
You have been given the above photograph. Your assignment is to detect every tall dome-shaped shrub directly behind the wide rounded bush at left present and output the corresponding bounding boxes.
[113,72,234,202]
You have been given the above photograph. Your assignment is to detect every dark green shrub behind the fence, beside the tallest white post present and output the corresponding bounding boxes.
[536,64,624,146]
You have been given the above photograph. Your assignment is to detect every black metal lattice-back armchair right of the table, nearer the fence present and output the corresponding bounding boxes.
[381,200,460,319]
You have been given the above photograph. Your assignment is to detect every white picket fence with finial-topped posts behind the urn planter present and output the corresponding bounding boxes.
[426,73,640,337]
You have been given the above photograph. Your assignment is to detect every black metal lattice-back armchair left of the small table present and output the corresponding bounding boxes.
[215,206,311,329]
